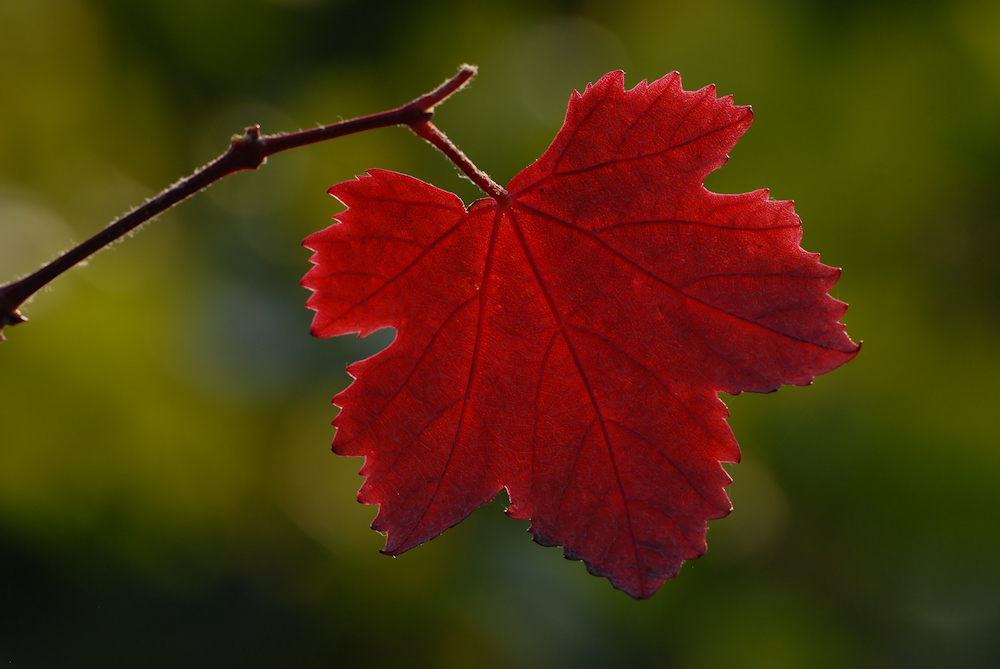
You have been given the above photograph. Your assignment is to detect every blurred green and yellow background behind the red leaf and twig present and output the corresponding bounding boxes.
[0,0,1000,669]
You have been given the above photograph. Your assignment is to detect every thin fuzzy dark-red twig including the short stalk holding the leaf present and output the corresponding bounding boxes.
[0,65,480,341]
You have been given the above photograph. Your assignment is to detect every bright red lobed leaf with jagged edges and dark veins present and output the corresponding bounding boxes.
[303,72,858,598]
